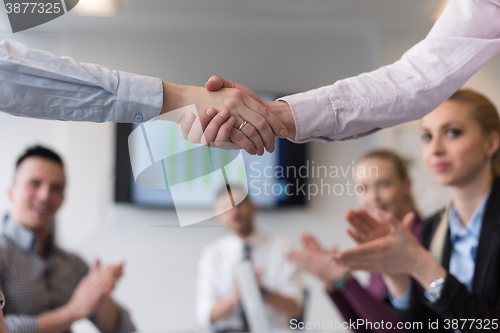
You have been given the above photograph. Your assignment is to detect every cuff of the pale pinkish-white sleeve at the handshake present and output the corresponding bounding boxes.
[278,89,336,143]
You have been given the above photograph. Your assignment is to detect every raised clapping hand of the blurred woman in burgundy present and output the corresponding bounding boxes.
[288,233,346,289]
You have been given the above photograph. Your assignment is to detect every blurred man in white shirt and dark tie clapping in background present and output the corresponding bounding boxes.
[196,186,303,332]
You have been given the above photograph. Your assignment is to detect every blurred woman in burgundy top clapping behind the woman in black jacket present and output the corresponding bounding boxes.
[289,149,422,333]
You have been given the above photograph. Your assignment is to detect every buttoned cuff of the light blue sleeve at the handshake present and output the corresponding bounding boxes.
[114,71,163,123]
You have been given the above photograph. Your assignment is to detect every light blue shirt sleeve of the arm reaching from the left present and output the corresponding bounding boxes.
[0,39,163,123]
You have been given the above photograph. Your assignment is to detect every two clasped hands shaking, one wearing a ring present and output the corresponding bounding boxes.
[160,76,295,156]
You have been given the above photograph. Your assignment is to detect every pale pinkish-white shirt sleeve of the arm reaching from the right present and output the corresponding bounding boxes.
[280,0,500,142]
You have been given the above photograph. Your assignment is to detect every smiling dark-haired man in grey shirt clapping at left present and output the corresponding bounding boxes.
[0,146,134,333]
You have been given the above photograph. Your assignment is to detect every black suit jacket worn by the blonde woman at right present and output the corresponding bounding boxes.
[394,177,500,333]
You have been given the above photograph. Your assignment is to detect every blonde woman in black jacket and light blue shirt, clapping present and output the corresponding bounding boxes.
[336,90,500,333]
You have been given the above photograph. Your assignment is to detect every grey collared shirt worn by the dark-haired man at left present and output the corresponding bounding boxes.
[0,218,135,333]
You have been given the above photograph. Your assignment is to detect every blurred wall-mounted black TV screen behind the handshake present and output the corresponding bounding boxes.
[115,94,307,209]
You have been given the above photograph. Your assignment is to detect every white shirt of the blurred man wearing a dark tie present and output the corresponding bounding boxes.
[196,231,303,330]
